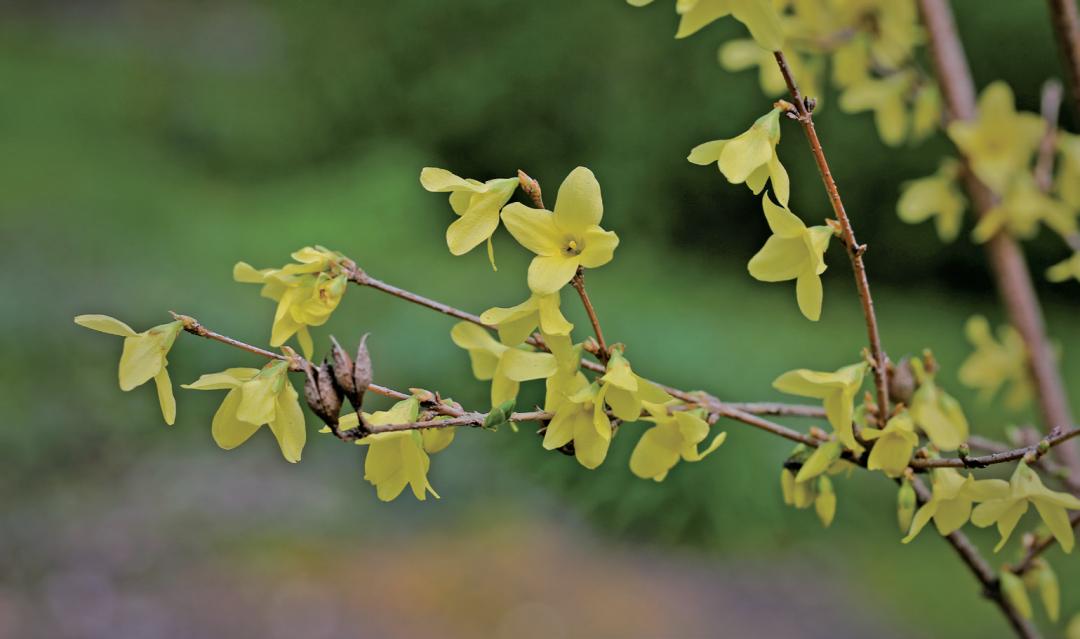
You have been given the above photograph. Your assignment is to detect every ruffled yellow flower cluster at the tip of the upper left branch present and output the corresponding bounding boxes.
[232,246,349,357]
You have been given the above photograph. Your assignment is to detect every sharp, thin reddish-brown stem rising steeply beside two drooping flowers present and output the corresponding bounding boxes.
[773,51,889,427]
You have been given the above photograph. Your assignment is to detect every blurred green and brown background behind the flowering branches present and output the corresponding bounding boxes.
[6,0,1080,638]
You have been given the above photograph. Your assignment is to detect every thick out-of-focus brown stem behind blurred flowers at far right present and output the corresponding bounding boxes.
[919,0,1080,475]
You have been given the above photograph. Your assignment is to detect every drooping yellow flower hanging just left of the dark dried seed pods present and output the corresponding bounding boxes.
[181,361,308,463]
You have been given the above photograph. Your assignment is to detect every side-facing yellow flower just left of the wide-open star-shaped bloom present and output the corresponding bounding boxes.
[420,166,519,269]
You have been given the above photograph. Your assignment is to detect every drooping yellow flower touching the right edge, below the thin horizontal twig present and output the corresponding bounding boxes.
[971,461,1080,553]
